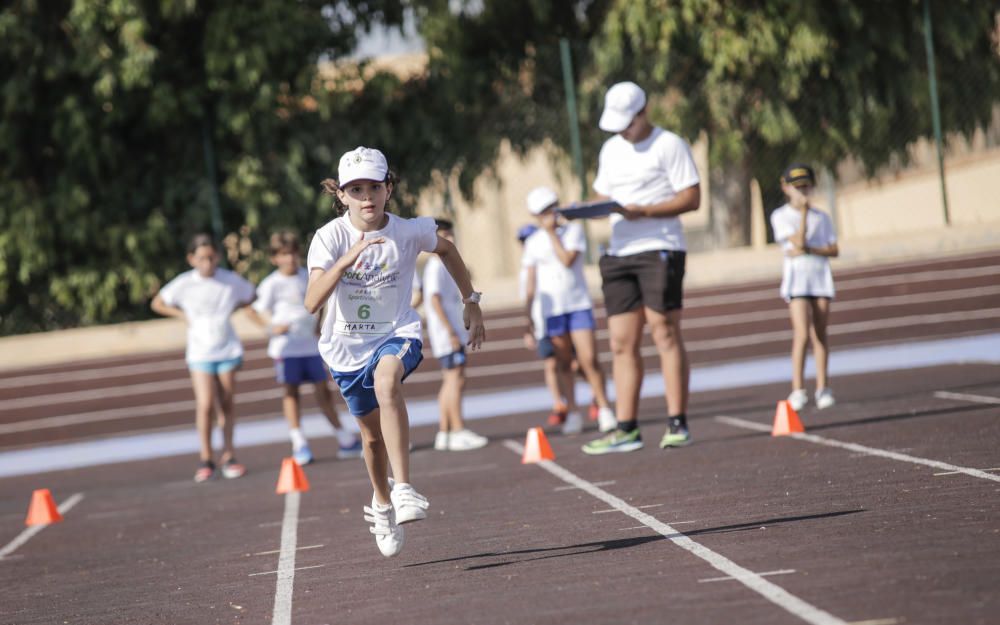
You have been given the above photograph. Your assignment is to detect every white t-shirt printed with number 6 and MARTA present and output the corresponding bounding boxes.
[307,213,437,372]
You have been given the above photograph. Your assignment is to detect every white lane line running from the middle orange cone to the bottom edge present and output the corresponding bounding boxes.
[504,441,846,625]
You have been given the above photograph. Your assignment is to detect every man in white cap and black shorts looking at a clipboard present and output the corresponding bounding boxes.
[583,82,701,454]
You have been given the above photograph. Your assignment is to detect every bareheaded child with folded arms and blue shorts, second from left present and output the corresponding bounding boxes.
[250,230,361,465]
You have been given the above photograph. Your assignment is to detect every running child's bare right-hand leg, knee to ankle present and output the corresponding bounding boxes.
[375,356,410,483]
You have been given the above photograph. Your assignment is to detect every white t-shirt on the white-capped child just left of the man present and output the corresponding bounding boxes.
[521,222,594,319]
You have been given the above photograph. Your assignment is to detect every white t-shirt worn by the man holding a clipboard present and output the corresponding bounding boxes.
[594,126,701,256]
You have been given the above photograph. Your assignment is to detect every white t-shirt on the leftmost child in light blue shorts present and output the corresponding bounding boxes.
[160,268,254,362]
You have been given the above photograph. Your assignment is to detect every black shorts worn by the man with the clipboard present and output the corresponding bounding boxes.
[599,250,687,316]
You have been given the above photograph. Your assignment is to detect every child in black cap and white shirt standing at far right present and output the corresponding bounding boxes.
[771,164,840,410]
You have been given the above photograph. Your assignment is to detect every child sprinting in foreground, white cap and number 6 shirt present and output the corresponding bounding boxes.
[305,147,486,557]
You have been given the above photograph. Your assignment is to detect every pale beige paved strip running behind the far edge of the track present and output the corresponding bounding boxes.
[0,223,1000,371]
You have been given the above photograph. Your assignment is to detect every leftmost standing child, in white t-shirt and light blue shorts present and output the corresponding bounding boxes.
[151,234,254,482]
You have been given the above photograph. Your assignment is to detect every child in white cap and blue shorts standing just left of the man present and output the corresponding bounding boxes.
[521,187,616,434]
